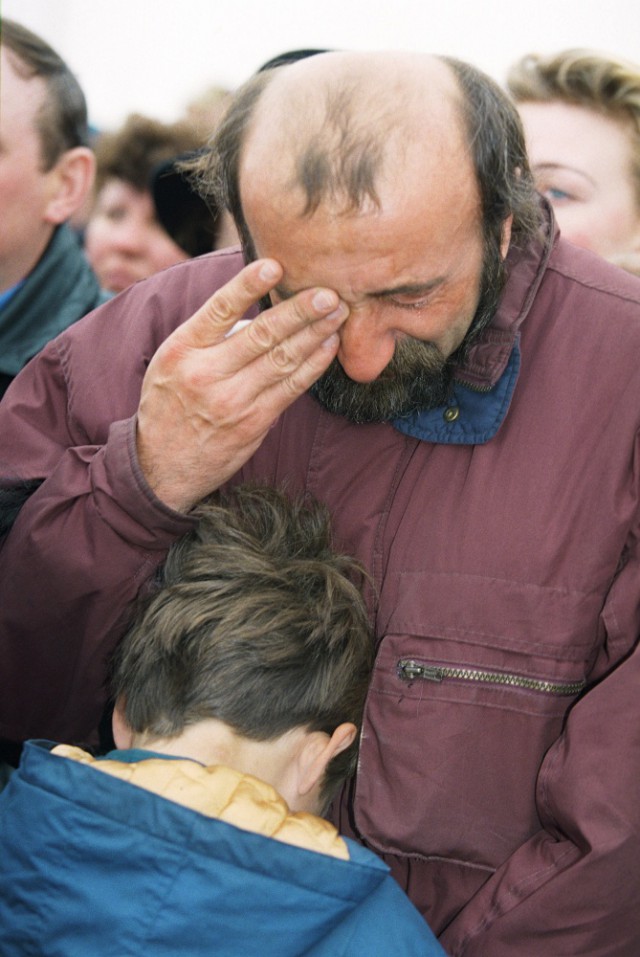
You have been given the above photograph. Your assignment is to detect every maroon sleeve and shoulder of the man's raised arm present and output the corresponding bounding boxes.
[0,250,250,742]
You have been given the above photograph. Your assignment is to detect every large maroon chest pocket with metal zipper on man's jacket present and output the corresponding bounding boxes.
[354,634,586,870]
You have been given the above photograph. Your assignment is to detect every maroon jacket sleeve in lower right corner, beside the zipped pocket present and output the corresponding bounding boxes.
[441,540,640,957]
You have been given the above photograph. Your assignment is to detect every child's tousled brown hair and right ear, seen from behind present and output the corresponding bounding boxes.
[114,487,373,802]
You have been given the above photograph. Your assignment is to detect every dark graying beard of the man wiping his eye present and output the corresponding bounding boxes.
[310,243,506,424]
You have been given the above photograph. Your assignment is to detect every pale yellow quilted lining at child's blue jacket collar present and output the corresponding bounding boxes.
[52,744,349,861]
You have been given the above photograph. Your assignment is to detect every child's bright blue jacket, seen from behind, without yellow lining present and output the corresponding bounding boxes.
[0,742,444,957]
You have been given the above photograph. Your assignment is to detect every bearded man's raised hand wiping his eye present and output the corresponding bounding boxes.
[137,259,348,511]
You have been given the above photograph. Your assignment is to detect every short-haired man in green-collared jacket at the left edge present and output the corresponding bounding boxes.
[0,19,107,396]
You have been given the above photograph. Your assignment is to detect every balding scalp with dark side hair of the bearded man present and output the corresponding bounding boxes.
[192,53,540,258]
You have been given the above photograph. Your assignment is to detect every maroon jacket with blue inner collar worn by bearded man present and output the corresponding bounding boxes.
[0,220,640,957]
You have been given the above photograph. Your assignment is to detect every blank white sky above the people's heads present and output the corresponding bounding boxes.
[5,0,640,128]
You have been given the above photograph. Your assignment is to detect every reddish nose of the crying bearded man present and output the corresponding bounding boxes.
[338,306,395,382]
